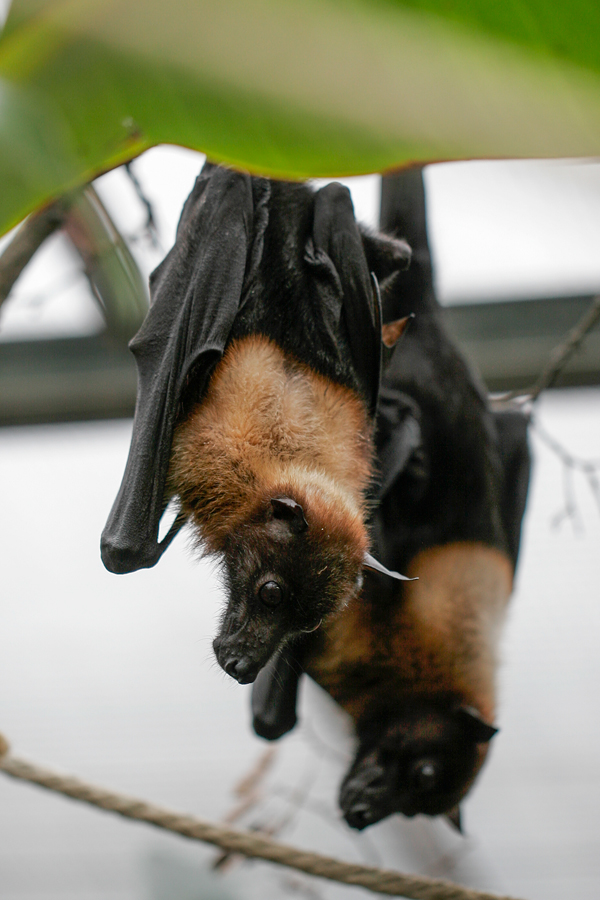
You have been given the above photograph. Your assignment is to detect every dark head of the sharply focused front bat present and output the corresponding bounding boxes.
[213,496,366,684]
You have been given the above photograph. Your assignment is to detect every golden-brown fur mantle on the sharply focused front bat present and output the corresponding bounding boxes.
[168,336,373,549]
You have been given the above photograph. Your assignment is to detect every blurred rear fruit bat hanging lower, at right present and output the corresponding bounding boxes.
[252,170,530,829]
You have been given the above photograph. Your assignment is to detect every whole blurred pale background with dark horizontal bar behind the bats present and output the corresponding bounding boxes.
[0,155,600,900]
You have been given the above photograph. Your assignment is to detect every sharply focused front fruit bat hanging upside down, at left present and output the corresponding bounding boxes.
[101,163,410,683]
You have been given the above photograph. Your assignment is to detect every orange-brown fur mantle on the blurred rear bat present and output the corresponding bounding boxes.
[307,542,512,721]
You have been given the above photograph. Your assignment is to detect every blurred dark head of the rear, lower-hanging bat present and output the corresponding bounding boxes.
[340,700,497,830]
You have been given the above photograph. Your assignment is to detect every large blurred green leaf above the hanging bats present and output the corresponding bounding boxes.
[0,0,600,236]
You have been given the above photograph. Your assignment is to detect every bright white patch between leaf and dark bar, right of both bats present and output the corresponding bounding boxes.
[425,159,600,306]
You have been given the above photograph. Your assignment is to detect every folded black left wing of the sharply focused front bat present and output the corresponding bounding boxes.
[101,165,266,574]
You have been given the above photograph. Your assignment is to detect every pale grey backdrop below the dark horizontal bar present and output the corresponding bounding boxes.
[0,390,600,900]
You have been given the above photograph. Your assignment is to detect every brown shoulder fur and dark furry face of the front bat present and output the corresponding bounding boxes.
[168,336,373,682]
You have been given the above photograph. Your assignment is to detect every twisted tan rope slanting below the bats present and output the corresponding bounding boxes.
[0,734,515,900]
